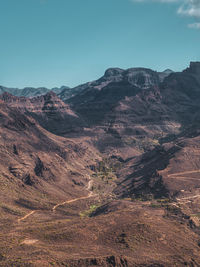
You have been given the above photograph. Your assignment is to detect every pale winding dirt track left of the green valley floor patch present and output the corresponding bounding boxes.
[18,178,97,222]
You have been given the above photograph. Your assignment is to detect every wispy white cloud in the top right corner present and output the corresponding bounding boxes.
[131,0,200,29]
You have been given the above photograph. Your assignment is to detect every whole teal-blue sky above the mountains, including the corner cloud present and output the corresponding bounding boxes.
[0,0,200,88]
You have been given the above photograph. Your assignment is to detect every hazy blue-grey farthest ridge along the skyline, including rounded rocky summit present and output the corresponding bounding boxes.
[0,68,173,101]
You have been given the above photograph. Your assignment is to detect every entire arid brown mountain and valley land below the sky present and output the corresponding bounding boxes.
[0,62,200,267]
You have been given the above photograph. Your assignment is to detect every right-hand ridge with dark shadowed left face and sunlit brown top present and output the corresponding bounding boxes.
[115,128,200,201]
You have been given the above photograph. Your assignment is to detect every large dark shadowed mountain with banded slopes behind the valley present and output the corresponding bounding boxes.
[62,63,199,155]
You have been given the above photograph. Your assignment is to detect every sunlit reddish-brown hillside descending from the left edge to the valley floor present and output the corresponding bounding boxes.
[0,100,98,211]
